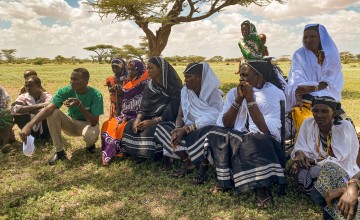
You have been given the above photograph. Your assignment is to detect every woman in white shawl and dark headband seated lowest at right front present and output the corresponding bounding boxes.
[290,96,360,219]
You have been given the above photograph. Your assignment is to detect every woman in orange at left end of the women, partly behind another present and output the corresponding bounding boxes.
[105,58,128,119]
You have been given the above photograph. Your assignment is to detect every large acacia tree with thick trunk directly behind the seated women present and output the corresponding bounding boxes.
[87,0,283,57]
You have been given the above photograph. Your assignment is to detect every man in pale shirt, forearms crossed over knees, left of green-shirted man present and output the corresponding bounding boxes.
[10,75,52,140]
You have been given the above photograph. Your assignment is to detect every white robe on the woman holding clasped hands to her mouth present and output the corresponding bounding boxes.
[217,82,285,141]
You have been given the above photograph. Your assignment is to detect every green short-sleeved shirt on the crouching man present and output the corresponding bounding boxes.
[52,86,104,121]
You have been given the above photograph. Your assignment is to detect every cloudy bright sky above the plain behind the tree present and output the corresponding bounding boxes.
[0,0,360,58]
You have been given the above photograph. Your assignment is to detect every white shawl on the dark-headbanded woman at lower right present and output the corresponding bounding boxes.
[291,118,360,177]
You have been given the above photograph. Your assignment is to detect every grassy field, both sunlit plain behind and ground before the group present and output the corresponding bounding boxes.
[0,63,360,219]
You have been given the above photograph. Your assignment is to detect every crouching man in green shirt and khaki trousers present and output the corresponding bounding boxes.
[20,68,104,165]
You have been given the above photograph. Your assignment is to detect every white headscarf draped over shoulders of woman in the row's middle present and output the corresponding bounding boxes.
[181,62,223,128]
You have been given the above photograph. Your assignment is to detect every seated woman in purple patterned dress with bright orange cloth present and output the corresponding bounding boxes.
[101,60,148,166]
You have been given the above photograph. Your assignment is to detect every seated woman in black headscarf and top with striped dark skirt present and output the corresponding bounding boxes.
[122,57,182,160]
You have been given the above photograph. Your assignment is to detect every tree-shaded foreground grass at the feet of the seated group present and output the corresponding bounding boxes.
[0,142,319,219]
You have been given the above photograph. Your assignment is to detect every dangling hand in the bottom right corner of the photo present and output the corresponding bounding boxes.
[337,183,358,219]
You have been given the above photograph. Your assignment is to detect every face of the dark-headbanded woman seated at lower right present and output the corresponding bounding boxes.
[312,104,335,127]
